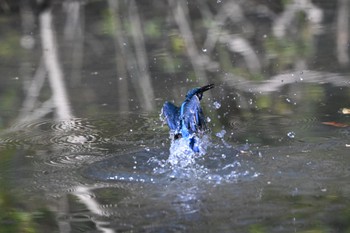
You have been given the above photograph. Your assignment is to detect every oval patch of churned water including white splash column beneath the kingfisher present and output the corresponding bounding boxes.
[85,129,260,183]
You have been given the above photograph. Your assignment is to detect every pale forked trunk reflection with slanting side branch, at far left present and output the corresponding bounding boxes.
[19,1,72,122]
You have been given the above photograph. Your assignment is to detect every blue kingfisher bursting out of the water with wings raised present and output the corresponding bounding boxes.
[161,84,214,152]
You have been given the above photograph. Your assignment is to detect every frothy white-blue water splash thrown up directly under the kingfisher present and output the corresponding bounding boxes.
[149,129,260,183]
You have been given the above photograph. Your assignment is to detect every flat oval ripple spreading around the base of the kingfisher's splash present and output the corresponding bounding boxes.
[83,145,259,183]
